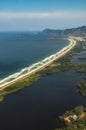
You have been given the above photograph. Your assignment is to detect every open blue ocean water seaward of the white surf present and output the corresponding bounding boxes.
[0,32,69,79]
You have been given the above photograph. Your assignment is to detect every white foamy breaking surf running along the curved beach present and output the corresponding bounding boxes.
[0,41,72,84]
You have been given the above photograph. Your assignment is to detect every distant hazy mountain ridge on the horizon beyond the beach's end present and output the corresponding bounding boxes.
[43,26,86,37]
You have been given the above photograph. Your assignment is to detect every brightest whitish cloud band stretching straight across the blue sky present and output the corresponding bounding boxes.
[0,12,86,19]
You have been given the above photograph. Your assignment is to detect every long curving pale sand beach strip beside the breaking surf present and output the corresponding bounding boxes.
[0,37,77,90]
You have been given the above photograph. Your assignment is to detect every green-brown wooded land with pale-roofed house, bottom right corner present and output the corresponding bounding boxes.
[55,106,86,130]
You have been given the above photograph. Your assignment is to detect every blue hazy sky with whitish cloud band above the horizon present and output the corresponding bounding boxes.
[0,0,86,32]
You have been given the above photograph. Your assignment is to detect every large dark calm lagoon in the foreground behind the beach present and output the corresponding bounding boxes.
[0,71,86,130]
